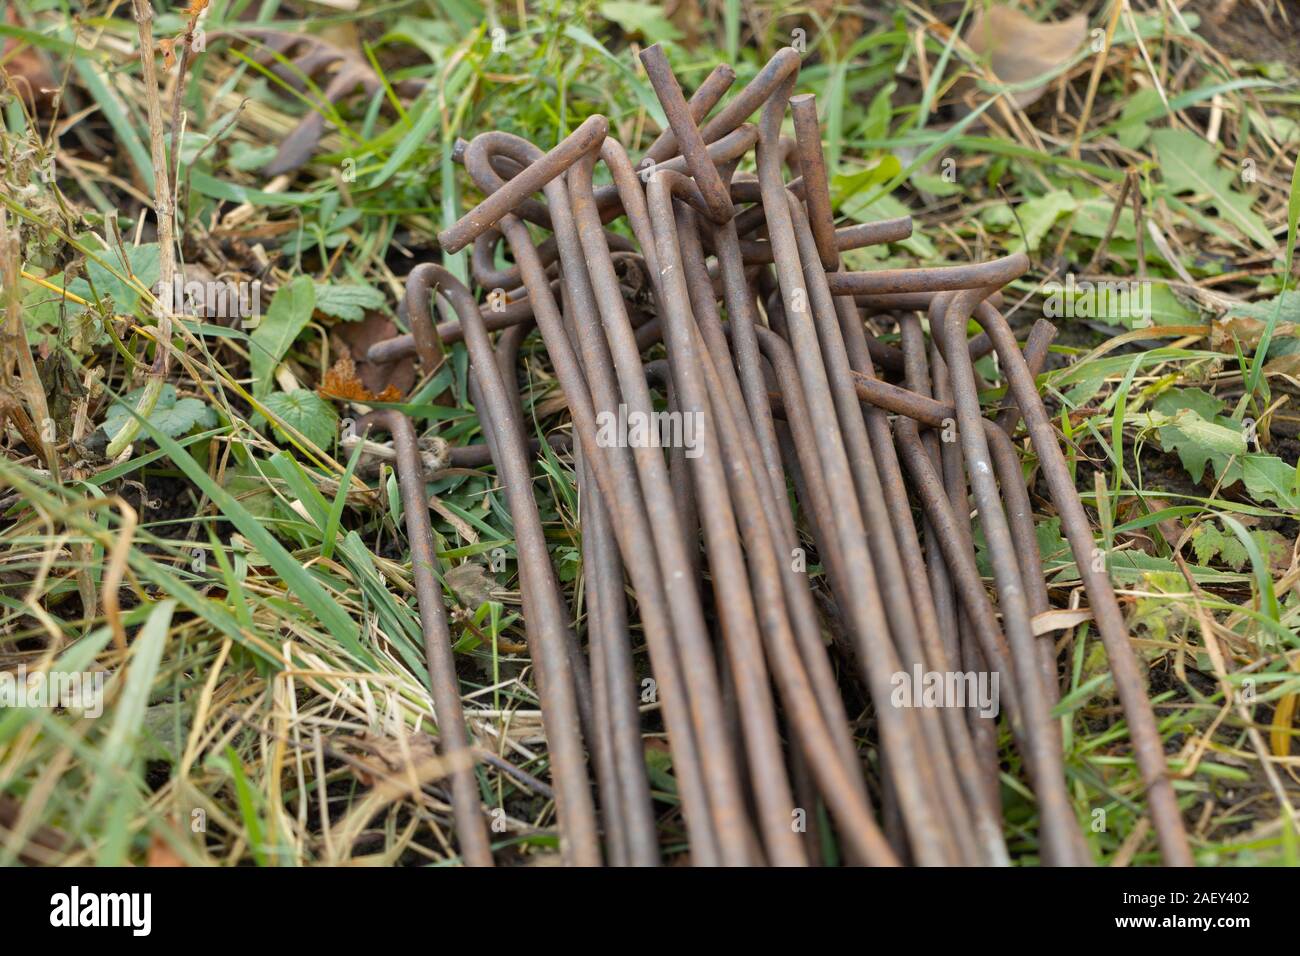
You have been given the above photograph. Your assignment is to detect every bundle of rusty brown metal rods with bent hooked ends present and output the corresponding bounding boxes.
[356,46,1191,865]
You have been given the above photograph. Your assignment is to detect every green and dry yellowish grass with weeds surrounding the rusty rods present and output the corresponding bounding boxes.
[0,0,1300,866]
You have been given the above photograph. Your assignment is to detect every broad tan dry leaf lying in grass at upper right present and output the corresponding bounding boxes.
[966,7,1088,108]
